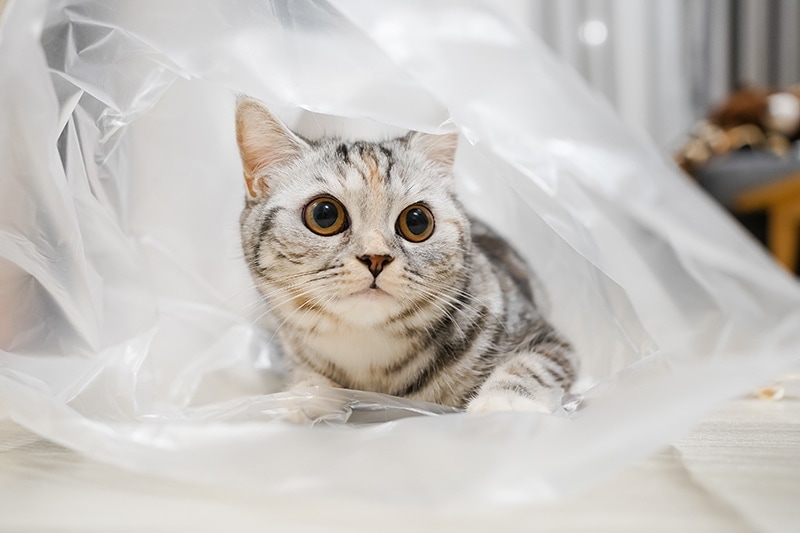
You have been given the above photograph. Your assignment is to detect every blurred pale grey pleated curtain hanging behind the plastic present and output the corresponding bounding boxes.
[506,0,800,149]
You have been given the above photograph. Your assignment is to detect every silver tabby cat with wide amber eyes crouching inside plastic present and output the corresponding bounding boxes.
[236,98,576,412]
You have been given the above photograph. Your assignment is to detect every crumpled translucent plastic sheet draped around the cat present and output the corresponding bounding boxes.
[0,0,800,513]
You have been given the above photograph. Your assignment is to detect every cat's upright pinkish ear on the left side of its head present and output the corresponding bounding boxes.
[236,97,308,200]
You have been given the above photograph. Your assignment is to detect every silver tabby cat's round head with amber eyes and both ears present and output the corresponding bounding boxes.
[236,99,470,327]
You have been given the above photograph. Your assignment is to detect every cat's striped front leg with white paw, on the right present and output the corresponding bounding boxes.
[467,352,574,413]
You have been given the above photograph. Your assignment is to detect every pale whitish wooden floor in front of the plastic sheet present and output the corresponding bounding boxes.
[0,396,800,533]
